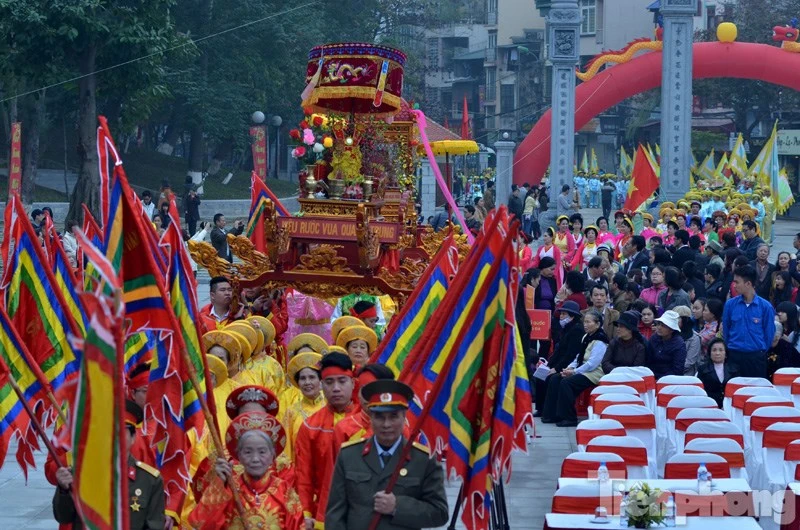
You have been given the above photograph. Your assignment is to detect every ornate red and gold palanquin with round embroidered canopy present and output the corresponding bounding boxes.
[189,44,469,305]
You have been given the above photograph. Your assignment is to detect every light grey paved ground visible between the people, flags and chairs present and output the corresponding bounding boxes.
[0,204,800,530]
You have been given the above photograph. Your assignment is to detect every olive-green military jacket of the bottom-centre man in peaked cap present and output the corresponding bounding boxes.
[325,437,449,530]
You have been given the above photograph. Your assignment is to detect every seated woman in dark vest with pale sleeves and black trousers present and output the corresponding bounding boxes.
[542,309,608,427]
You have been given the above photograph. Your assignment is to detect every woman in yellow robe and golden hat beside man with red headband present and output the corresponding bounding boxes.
[281,352,325,459]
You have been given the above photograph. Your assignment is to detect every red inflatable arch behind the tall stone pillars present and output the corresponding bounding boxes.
[514,42,800,184]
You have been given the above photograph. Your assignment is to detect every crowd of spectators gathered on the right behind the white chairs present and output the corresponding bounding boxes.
[516,196,800,427]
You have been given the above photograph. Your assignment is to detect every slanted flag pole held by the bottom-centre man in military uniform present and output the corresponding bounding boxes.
[369,227,519,530]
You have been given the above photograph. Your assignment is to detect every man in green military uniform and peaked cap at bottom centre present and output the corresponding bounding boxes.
[325,380,448,530]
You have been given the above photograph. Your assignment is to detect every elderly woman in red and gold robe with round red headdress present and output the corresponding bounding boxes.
[189,412,305,530]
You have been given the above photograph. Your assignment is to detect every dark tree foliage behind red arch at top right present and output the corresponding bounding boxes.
[693,0,800,141]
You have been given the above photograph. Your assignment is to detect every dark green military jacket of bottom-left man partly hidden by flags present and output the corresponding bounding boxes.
[53,458,166,530]
